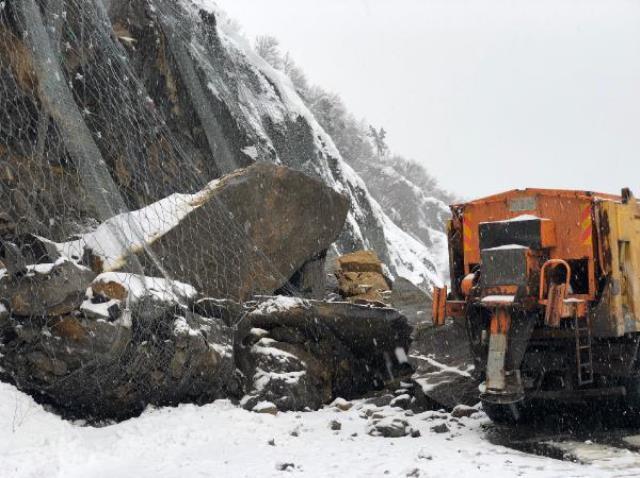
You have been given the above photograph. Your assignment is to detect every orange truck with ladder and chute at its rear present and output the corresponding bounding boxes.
[433,189,640,422]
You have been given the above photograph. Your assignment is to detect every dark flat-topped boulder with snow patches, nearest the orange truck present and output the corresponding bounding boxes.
[236,297,411,410]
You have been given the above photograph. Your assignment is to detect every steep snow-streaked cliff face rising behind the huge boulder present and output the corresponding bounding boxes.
[0,0,439,288]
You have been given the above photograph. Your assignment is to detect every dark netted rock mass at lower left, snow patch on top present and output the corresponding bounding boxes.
[0,270,239,420]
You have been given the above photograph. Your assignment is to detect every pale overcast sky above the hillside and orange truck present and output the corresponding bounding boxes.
[217,0,640,198]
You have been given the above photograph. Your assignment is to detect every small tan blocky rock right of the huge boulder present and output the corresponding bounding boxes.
[335,251,391,306]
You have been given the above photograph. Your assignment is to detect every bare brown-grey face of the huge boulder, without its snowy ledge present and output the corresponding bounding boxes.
[144,163,349,301]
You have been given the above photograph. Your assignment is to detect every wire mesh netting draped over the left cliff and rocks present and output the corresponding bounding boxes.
[0,0,316,415]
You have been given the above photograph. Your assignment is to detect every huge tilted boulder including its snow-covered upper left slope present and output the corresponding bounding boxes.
[59,163,349,301]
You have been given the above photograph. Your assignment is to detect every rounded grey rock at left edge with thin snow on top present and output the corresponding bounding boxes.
[0,259,95,317]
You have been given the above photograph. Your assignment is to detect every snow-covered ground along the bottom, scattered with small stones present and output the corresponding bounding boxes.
[0,383,640,478]
